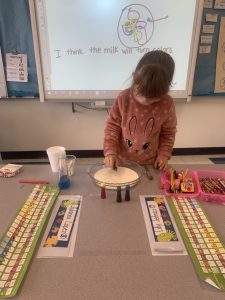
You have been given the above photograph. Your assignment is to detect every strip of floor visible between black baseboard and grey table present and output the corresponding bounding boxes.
[3,155,225,165]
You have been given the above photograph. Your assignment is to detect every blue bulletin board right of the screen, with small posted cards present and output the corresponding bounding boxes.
[192,0,225,96]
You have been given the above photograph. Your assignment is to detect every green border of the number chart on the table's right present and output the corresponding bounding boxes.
[167,197,225,291]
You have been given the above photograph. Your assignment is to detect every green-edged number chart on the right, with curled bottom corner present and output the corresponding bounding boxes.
[168,197,225,291]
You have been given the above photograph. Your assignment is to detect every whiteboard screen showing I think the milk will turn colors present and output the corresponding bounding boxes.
[30,0,202,102]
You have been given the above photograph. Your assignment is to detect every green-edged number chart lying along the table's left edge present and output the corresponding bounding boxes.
[0,185,59,298]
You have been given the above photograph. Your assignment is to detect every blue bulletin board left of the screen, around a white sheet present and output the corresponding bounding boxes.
[0,0,39,97]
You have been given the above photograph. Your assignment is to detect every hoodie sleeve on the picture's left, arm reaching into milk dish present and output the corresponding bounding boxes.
[103,96,122,156]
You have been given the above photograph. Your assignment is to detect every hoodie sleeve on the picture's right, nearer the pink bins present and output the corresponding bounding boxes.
[158,101,177,159]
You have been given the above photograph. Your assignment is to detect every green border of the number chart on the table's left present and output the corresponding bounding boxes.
[0,185,60,298]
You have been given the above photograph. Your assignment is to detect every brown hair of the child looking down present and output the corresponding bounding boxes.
[132,50,175,98]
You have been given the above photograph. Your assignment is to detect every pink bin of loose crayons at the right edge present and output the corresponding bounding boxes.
[195,170,225,203]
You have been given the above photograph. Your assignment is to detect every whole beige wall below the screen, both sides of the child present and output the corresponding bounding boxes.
[0,97,225,152]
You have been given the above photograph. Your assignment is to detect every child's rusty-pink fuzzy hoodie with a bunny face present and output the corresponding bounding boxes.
[104,89,177,164]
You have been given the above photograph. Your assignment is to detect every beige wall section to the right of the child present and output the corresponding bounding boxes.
[175,97,225,148]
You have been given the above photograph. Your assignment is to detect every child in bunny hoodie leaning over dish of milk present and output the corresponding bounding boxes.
[104,50,177,170]
